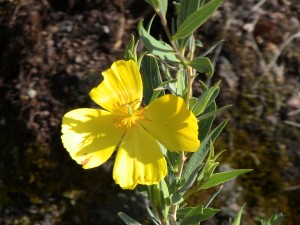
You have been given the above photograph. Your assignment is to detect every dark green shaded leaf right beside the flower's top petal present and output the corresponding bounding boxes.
[141,56,162,105]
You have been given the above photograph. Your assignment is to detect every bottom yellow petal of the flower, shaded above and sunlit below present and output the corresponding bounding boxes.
[113,124,167,189]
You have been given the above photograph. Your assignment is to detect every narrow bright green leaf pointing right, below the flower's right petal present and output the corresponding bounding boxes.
[199,169,252,190]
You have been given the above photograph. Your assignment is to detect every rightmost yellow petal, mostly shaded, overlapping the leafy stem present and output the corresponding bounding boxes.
[138,95,200,152]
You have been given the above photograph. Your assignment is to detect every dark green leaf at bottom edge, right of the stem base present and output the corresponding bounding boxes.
[177,206,220,225]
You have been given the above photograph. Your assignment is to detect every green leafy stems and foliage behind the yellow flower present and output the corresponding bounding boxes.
[119,0,282,225]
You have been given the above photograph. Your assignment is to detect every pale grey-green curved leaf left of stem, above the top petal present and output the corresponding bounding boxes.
[138,21,179,62]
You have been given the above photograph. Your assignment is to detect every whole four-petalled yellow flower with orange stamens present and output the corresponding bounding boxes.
[62,60,200,189]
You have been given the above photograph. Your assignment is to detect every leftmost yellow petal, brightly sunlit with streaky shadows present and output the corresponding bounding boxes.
[61,108,125,169]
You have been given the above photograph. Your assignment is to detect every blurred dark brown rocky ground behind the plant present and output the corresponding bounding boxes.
[0,0,300,225]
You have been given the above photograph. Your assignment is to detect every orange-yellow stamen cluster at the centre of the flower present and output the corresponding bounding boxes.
[114,100,145,127]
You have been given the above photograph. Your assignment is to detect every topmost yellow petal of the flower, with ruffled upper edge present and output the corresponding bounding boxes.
[90,60,143,112]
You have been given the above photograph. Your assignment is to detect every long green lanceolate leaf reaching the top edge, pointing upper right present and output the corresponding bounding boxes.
[173,0,223,39]
